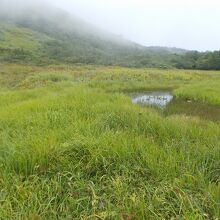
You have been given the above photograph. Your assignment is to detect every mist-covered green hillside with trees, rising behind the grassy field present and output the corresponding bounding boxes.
[0,2,220,69]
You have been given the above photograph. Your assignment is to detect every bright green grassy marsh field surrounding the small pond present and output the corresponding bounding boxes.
[0,64,220,220]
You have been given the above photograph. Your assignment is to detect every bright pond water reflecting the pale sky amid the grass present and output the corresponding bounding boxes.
[132,91,173,108]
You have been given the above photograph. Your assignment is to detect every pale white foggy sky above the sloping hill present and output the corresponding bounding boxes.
[0,0,220,51]
